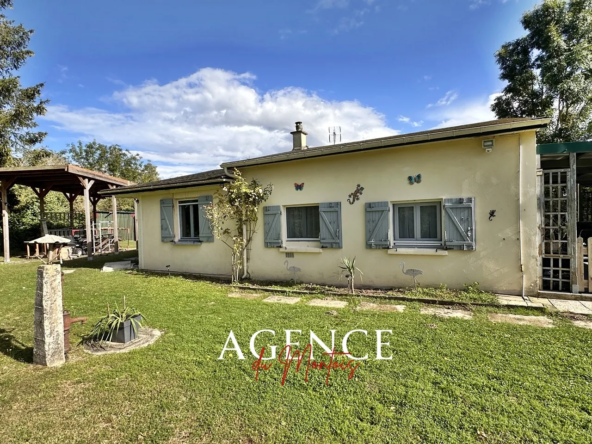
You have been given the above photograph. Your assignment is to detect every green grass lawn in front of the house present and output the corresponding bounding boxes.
[0,252,592,443]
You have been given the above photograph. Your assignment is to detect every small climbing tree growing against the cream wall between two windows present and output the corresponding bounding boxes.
[206,169,273,282]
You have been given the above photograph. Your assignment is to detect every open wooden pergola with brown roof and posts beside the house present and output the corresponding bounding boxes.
[0,164,134,262]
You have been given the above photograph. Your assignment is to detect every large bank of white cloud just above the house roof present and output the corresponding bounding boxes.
[43,68,397,177]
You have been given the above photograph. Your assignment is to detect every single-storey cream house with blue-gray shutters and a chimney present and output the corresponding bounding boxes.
[104,118,556,295]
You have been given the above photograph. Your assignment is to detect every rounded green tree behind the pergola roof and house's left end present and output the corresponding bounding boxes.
[60,140,159,183]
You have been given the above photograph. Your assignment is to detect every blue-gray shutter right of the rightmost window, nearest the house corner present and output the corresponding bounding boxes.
[444,197,475,250]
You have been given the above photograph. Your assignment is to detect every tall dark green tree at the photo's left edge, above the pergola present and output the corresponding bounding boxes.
[0,0,48,167]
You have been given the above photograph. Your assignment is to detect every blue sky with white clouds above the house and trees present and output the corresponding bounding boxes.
[7,0,536,177]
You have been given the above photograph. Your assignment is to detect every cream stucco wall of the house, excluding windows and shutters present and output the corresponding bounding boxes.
[138,131,538,294]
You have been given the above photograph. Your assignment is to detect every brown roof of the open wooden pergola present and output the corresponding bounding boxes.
[0,164,134,197]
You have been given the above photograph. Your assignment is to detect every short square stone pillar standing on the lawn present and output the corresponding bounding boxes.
[33,265,66,367]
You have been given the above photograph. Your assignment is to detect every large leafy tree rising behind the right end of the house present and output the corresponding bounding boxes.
[492,0,592,143]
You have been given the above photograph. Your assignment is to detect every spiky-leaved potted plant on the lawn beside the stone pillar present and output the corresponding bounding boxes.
[83,298,145,344]
